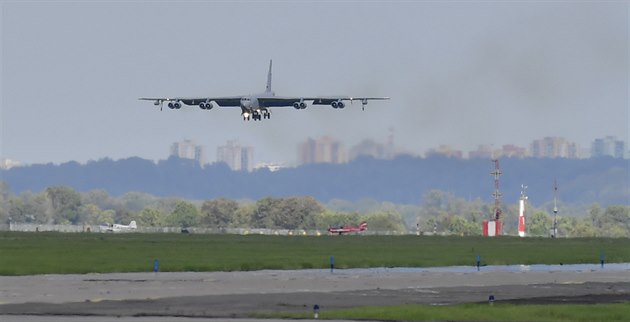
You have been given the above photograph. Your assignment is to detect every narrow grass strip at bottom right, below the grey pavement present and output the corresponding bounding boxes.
[258,303,630,322]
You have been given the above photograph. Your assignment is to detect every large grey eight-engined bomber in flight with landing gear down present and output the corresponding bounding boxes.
[140,60,389,121]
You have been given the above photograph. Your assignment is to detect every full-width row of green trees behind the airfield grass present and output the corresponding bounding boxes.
[0,182,630,237]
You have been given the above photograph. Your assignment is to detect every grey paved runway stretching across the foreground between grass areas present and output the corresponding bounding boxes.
[0,266,630,322]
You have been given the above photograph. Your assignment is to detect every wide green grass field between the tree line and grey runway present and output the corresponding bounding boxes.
[0,232,630,275]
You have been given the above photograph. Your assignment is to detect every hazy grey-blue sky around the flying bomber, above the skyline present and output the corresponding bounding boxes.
[0,1,630,163]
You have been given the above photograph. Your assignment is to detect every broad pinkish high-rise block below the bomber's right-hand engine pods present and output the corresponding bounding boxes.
[298,136,347,164]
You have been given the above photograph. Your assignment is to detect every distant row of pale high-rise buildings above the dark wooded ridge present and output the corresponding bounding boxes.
[0,135,630,172]
